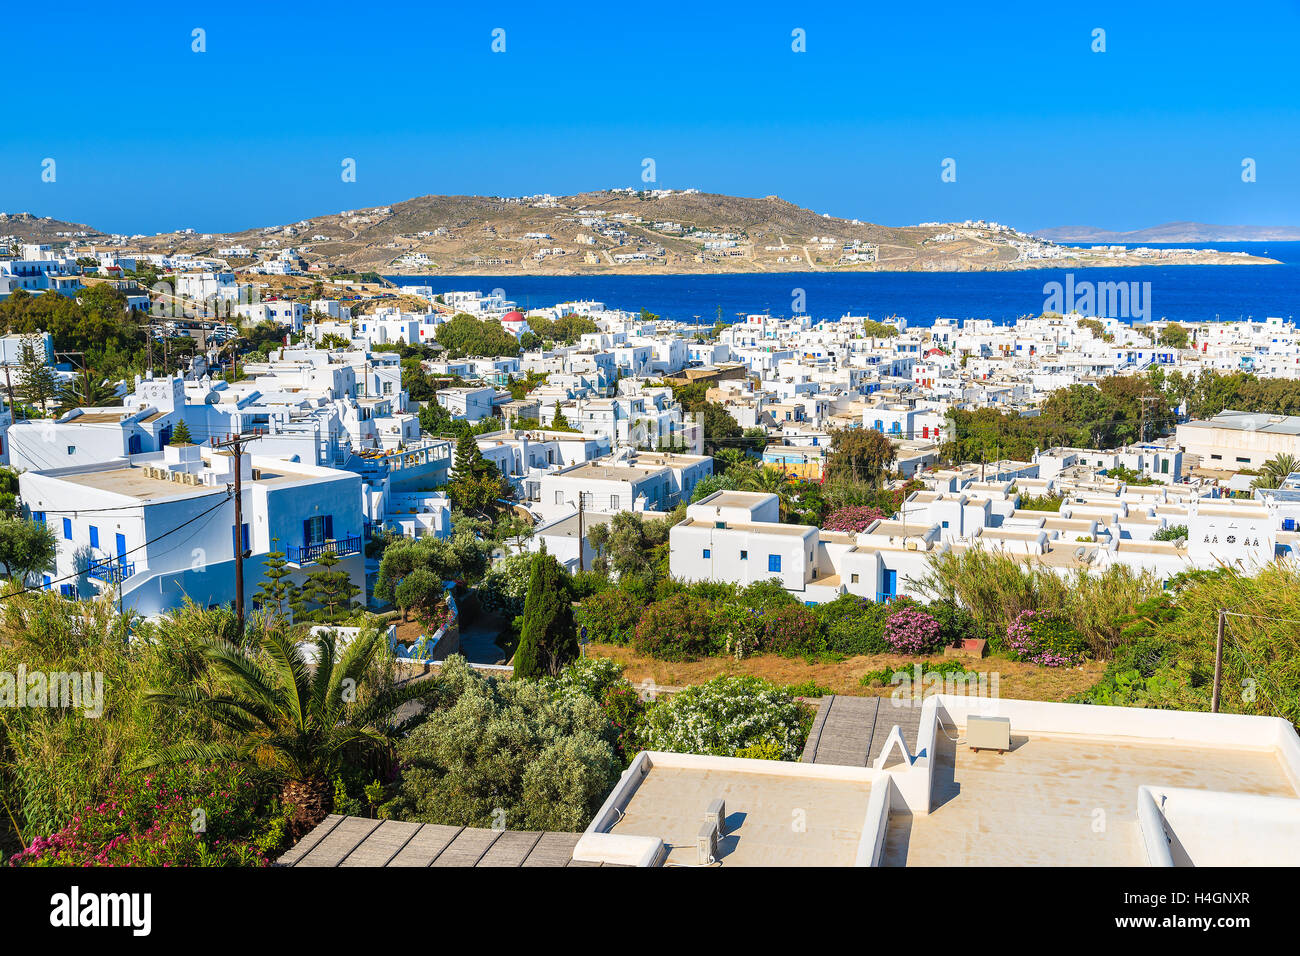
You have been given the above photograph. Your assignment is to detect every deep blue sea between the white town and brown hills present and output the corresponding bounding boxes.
[390,242,1300,325]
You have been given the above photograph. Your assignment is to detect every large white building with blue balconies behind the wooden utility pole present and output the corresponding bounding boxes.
[20,445,365,615]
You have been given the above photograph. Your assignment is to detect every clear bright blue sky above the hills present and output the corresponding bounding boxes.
[0,0,1300,232]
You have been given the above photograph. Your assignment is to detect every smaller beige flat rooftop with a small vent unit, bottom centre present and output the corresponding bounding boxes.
[610,766,872,866]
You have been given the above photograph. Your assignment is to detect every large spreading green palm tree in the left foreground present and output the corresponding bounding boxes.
[137,627,434,838]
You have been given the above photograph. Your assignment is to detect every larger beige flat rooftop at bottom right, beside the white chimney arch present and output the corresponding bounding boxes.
[881,721,1297,866]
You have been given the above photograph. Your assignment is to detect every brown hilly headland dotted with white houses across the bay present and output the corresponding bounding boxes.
[0,195,1274,278]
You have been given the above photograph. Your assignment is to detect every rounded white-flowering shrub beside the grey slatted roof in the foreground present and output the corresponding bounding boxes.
[644,676,805,760]
